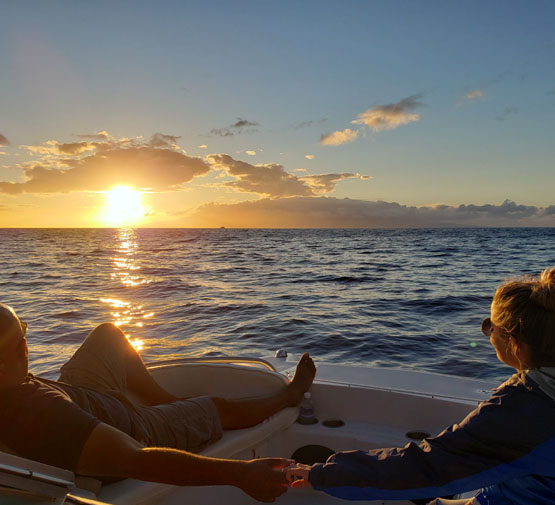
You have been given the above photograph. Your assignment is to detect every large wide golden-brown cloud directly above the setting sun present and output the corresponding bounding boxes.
[0,145,210,194]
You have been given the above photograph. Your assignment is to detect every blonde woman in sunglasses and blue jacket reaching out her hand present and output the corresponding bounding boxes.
[288,268,555,505]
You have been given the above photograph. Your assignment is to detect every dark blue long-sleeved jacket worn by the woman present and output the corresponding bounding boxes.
[309,370,555,505]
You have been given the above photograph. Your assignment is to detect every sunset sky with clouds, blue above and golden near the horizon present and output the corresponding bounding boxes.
[0,0,555,228]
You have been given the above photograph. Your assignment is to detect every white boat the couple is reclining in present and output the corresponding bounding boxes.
[0,351,495,505]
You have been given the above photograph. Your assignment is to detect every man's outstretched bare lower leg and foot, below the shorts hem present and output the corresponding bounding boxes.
[212,353,316,430]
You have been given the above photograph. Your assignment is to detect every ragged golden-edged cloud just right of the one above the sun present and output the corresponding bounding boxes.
[207,154,358,198]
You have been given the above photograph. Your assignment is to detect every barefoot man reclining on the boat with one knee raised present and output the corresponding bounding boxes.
[0,304,316,501]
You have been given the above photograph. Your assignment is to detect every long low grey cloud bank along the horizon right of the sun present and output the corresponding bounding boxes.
[193,197,555,228]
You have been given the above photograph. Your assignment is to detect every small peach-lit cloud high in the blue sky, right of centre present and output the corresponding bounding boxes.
[351,95,422,132]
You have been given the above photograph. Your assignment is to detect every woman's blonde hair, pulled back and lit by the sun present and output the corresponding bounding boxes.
[493,268,555,368]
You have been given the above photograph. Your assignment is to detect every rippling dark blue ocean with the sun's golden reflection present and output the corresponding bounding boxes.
[0,228,555,380]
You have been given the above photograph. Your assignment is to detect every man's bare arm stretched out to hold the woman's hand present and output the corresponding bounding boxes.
[77,423,293,501]
